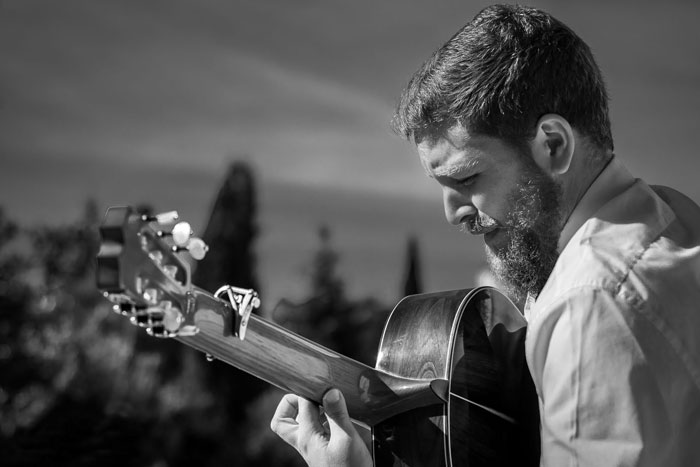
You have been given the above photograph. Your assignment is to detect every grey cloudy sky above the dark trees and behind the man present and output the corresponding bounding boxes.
[0,0,700,310]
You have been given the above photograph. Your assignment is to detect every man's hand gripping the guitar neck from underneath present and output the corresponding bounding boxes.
[270,389,372,467]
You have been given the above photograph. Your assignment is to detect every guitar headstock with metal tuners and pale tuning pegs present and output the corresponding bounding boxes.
[97,206,208,337]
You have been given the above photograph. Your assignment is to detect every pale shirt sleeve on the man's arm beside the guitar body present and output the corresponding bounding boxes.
[528,288,664,467]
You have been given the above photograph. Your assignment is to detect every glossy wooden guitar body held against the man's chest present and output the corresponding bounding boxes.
[372,288,540,467]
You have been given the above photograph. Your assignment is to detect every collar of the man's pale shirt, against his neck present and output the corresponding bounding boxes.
[558,157,635,253]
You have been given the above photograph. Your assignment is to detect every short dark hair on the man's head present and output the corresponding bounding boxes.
[393,5,613,150]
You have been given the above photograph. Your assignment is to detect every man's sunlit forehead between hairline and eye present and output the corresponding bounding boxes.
[417,127,518,177]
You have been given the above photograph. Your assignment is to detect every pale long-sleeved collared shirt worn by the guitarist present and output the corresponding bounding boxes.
[525,160,700,467]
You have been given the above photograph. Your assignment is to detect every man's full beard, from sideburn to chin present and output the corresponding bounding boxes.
[483,161,563,304]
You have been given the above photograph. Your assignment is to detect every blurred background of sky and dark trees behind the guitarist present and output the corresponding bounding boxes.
[0,0,700,466]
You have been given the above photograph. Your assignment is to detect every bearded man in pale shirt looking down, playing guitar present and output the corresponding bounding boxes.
[272,6,700,467]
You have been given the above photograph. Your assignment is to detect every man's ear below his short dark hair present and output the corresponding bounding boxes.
[530,114,576,175]
